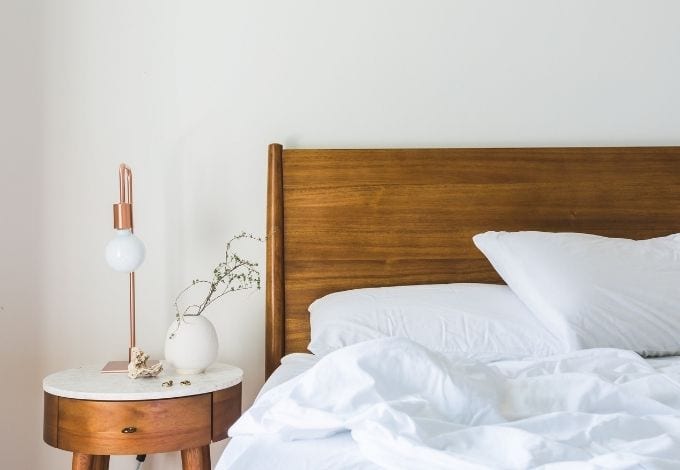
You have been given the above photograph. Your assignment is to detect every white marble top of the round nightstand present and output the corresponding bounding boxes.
[43,362,243,401]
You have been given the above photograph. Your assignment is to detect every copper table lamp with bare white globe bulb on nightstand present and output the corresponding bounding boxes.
[102,163,145,372]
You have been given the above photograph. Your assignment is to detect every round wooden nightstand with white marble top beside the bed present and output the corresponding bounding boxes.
[43,364,243,470]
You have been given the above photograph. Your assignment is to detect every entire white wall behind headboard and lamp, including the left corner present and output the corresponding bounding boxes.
[0,0,680,470]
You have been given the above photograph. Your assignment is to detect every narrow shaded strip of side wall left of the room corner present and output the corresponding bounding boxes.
[0,0,46,469]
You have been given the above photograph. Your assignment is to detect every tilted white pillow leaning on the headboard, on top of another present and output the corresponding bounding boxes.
[473,232,680,356]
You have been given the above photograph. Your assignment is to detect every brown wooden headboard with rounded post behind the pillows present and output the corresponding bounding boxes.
[266,144,680,376]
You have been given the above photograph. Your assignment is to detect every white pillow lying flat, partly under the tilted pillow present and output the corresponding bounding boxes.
[309,284,567,361]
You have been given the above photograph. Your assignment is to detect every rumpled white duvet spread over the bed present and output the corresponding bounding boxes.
[230,338,680,469]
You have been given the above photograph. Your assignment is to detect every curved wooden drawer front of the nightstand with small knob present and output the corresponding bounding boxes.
[57,393,212,455]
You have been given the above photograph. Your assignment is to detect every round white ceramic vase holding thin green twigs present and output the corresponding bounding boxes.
[165,315,218,374]
